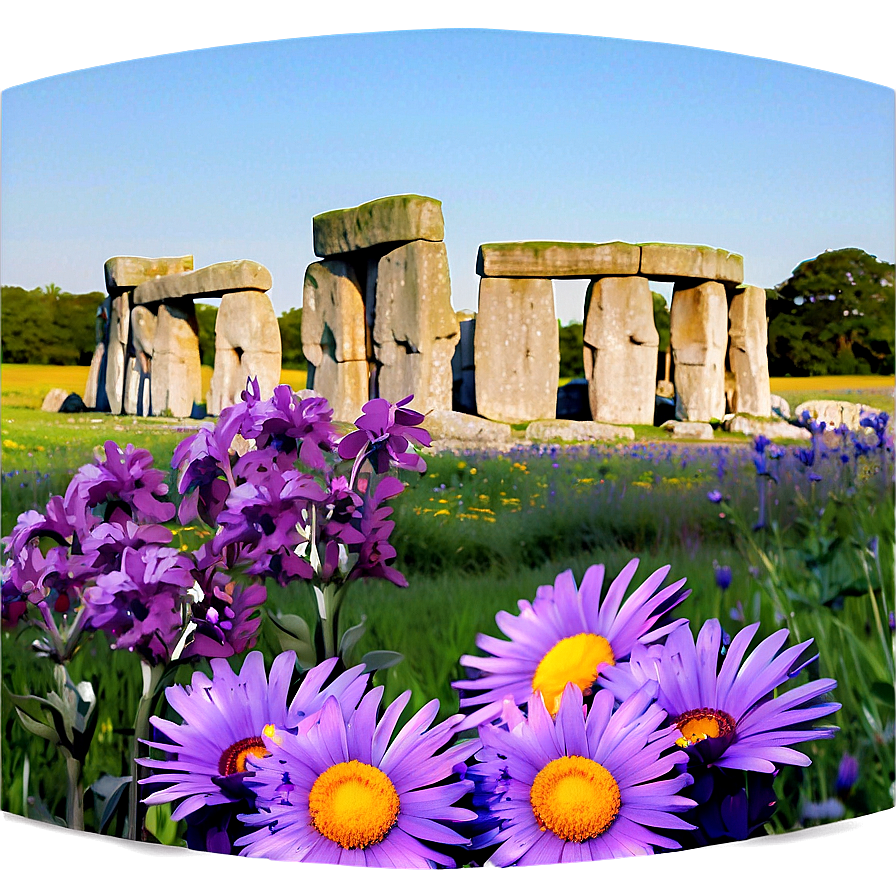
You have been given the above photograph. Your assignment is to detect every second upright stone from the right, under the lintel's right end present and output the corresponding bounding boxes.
[671,280,728,421]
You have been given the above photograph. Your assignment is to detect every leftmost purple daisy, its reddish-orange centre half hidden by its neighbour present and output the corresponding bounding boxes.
[137,650,367,821]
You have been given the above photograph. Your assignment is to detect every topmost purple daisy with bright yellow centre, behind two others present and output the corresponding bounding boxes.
[453,559,690,727]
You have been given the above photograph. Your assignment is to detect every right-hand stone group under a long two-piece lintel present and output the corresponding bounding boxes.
[475,241,771,424]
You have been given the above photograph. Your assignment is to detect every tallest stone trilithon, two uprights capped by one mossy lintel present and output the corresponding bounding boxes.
[302,194,460,420]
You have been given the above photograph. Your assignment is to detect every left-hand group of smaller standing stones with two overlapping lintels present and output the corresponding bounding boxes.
[85,255,281,417]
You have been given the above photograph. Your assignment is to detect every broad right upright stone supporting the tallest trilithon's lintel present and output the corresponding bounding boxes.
[368,240,460,413]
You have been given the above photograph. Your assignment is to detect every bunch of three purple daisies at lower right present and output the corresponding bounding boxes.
[454,561,839,865]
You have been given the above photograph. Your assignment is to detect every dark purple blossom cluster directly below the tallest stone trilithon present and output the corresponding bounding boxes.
[173,381,429,586]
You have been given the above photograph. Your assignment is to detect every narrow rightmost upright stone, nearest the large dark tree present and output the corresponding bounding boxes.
[728,286,772,417]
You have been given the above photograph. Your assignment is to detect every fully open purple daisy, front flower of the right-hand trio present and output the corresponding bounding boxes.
[474,683,696,867]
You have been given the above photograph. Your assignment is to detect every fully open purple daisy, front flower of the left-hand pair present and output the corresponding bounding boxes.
[235,687,479,868]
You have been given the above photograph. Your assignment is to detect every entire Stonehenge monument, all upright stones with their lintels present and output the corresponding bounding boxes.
[85,194,772,437]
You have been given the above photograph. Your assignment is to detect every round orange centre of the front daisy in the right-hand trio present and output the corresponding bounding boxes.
[529,756,620,843]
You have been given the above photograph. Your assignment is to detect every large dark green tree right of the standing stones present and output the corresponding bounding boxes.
[767,249,896,376]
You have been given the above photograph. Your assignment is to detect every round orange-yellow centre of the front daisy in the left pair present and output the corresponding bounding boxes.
[308,759,399,849]
